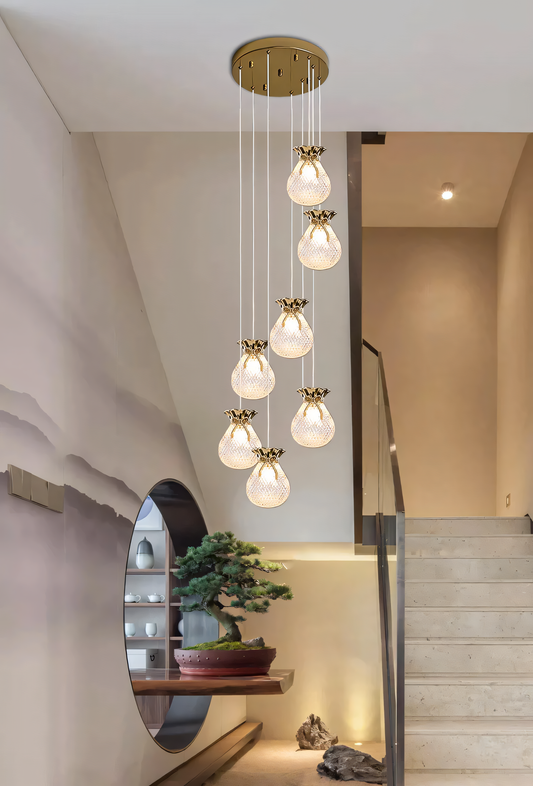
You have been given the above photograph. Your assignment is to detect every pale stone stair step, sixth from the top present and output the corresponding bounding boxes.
[405,637,533,676]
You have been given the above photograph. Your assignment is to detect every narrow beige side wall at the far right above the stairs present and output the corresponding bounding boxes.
[497,136,533,516]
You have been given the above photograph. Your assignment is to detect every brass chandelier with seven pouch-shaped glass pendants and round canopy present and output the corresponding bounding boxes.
[218,38,341,508]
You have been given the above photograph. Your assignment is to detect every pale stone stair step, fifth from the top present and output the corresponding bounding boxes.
[405,606,533,638]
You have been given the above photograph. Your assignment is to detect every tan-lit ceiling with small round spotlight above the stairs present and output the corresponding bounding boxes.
[363,133,527,227]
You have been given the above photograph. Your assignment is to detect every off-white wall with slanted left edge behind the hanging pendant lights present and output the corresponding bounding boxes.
[96,130,353,542]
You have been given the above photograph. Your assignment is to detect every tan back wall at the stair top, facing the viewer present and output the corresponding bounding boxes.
[363,228,496,516]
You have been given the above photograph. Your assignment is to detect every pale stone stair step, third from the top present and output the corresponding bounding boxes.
[405,556,533,582]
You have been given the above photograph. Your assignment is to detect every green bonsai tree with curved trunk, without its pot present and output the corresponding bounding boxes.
[173,532,293,644]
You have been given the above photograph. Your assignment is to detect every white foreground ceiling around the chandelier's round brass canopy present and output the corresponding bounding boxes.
[0,0,533,131]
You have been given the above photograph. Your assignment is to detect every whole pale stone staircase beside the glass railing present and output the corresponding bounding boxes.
[405,518,533,786]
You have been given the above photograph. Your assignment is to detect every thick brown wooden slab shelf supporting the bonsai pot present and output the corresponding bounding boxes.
[131,669,294,696]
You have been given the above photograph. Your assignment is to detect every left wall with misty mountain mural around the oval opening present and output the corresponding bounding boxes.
[0,18,245,786]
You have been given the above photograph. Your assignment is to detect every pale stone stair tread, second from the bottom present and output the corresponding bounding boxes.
[405,717,533,736]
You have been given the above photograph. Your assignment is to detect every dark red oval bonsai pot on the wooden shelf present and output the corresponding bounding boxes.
[174,647,276,677]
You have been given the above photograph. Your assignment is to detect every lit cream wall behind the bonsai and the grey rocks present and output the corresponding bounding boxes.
[244,561,382,742]
